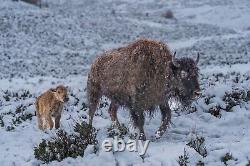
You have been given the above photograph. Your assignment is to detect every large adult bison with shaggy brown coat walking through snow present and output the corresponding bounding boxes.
[87,39,200,139]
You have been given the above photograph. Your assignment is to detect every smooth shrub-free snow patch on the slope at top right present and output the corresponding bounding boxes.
[175,1,250,31]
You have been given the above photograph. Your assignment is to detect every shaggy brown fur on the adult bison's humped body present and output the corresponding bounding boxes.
[87,39,171,106]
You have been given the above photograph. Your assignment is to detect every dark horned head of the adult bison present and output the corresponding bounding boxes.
[170,53,200,106]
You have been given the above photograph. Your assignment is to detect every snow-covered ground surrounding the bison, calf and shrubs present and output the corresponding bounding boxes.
[0,0,250,166]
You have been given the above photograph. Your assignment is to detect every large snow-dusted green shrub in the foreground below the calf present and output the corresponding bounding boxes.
[34,122,98,163]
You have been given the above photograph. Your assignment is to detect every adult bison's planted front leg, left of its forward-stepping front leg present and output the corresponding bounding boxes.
[130,109,146,141]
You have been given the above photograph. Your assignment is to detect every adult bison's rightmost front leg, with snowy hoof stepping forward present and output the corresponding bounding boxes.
[155,105,171,138]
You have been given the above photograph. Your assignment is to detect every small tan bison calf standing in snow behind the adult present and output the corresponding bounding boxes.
[35,85,69,130]
